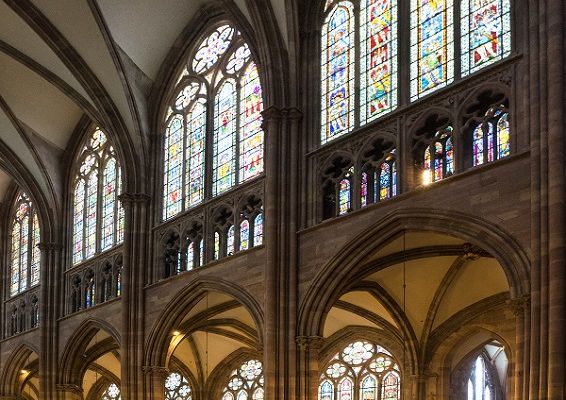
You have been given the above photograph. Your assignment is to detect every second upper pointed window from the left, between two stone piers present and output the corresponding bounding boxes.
[69,125,125,268]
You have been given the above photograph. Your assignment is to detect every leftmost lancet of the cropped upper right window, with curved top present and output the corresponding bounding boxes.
[321,1,355,144]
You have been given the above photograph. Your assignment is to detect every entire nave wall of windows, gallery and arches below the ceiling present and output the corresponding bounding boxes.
[0,0,552,400]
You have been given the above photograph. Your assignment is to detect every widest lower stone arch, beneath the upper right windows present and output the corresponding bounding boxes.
[298,208,530,336]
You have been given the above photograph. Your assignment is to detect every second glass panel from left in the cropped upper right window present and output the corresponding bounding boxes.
[360,0,397,123]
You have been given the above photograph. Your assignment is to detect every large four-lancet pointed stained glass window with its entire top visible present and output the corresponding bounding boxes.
[158,20,265,222]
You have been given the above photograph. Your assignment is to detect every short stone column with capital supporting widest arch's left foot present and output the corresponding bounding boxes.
[296,336,323,400]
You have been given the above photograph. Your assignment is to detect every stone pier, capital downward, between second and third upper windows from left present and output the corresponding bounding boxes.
[120,193,151,400]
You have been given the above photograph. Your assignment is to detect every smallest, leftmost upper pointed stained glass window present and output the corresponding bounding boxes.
[10,192,41,296]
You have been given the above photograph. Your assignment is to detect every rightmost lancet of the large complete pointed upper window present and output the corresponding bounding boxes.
[239,62,263,182]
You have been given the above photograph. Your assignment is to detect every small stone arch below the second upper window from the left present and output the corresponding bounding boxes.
[59,318,120,387]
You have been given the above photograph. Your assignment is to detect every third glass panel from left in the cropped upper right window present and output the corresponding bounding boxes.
[410,0,454,100]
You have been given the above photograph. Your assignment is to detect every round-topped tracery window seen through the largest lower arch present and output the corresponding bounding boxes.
[317,339,404,400]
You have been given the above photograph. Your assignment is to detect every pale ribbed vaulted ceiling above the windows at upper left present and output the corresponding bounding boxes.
[0,0,288,209]
